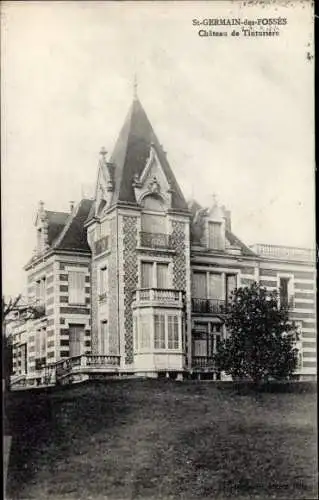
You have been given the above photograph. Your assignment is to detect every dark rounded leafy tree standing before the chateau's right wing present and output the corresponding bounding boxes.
[215,283,298,383]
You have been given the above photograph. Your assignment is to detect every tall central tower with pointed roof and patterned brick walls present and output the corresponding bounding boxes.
[87,93,191,374]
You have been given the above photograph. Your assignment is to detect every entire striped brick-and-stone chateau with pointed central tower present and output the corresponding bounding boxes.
[12,97,316,388]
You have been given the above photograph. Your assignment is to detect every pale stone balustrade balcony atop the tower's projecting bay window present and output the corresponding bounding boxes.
[133,288,183,308]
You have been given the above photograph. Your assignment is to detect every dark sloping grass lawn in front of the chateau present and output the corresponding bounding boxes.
[6,380,317,500]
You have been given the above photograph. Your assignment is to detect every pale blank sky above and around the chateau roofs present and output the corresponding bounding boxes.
[1,1,314,294]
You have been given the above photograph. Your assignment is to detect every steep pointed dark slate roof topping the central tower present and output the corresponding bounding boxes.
[110,98,188,210]
